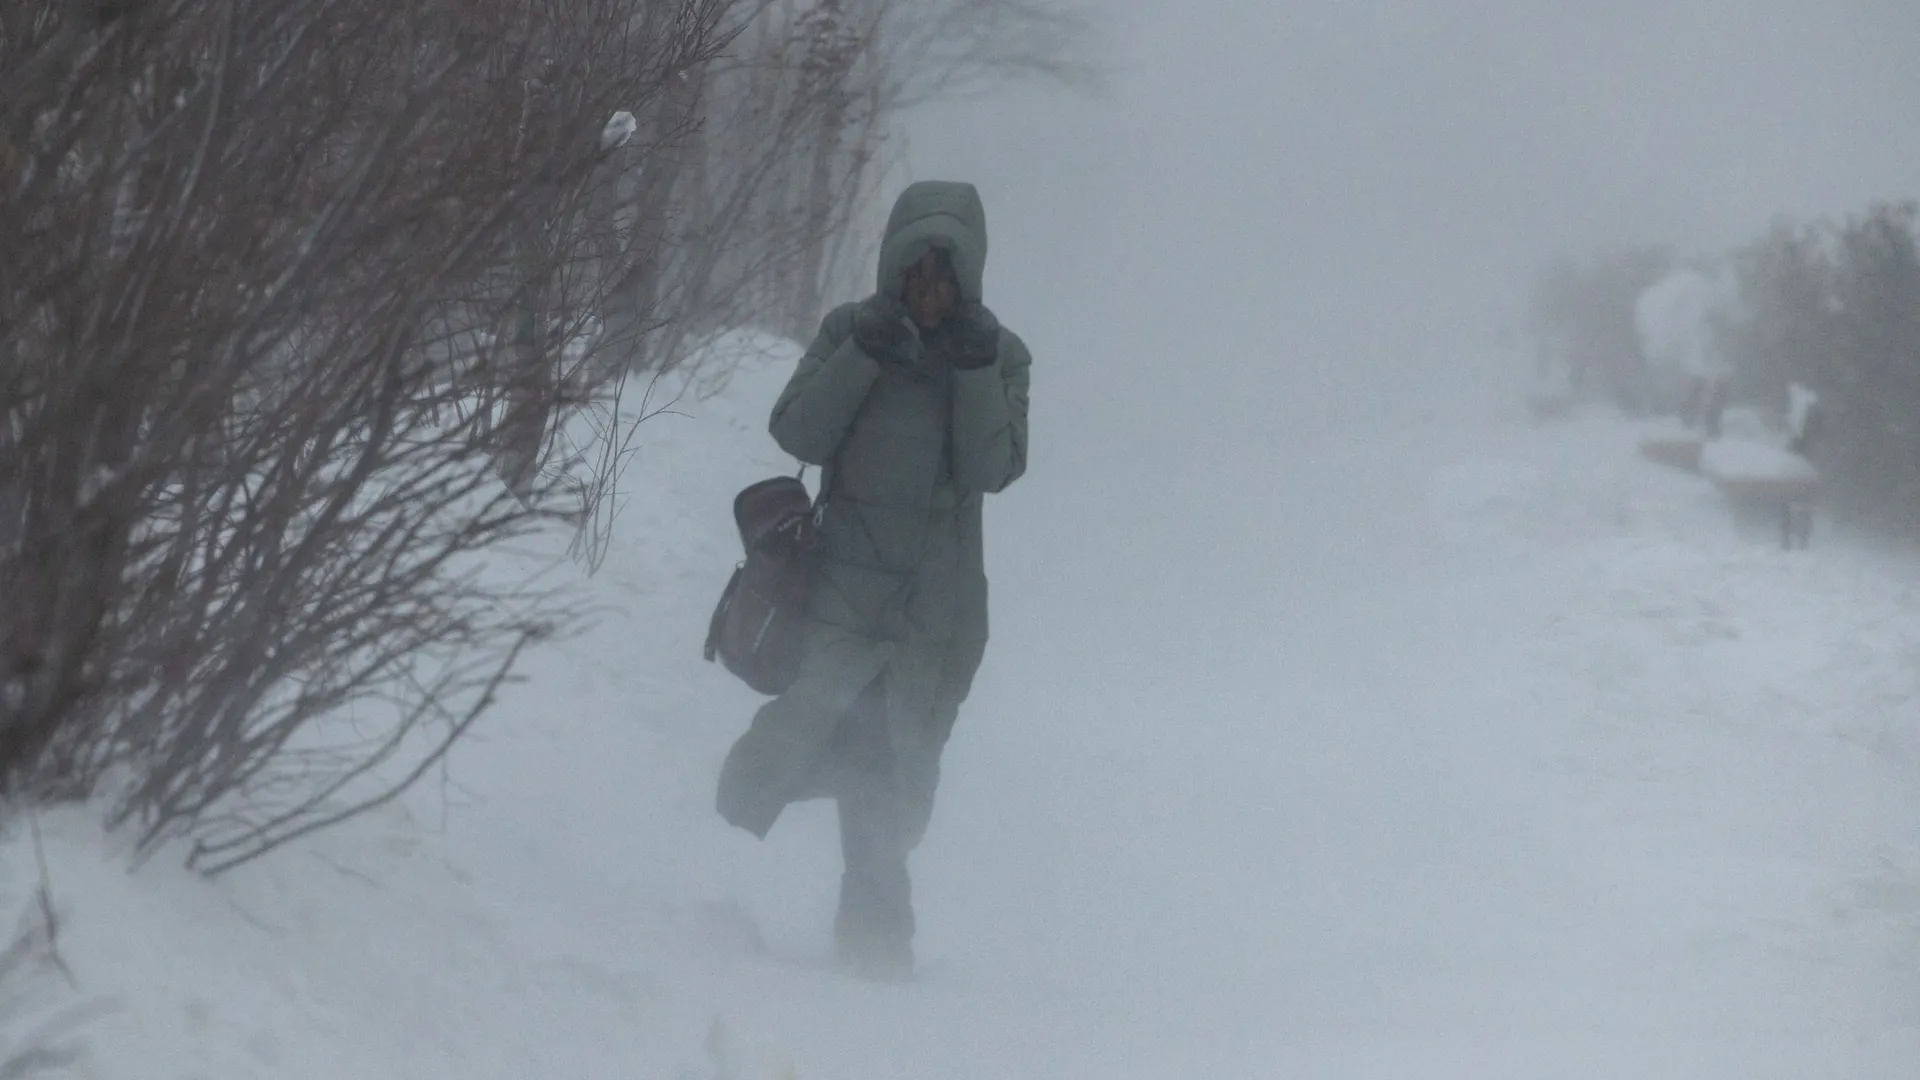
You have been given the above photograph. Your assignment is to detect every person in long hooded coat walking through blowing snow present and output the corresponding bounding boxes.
[716,181,1033,980]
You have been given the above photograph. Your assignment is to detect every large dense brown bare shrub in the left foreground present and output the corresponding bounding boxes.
[0,0,726,871]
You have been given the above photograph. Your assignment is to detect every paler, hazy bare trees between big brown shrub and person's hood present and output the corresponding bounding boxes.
[605,0,1102,368]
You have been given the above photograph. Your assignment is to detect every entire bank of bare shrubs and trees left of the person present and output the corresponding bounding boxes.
[0,0,1105,872]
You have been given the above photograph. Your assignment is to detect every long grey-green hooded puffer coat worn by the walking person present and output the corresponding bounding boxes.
[718,183,1033,842]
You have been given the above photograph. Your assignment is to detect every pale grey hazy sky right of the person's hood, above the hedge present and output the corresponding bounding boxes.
[912,0,1920,378]
